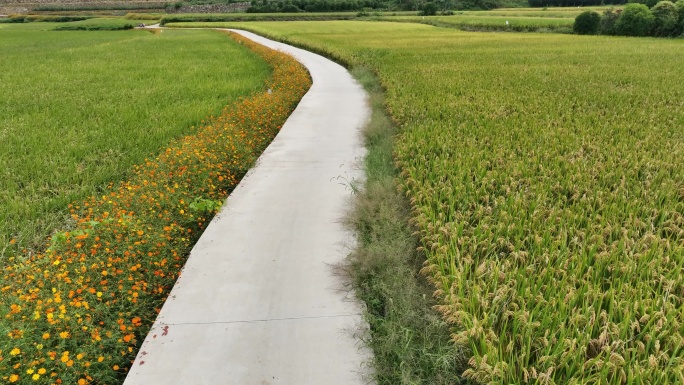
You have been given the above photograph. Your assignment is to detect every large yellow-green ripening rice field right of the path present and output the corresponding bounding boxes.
[196,21,684,384]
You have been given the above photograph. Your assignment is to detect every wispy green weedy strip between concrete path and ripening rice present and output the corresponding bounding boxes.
[346,67,467,385]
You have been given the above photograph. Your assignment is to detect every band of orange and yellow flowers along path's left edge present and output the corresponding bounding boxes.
[0,35,311,384]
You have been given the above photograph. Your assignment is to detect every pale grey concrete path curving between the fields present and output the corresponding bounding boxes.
[124,31,369,385]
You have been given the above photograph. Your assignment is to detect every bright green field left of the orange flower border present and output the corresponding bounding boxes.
[0,20,270,258]
